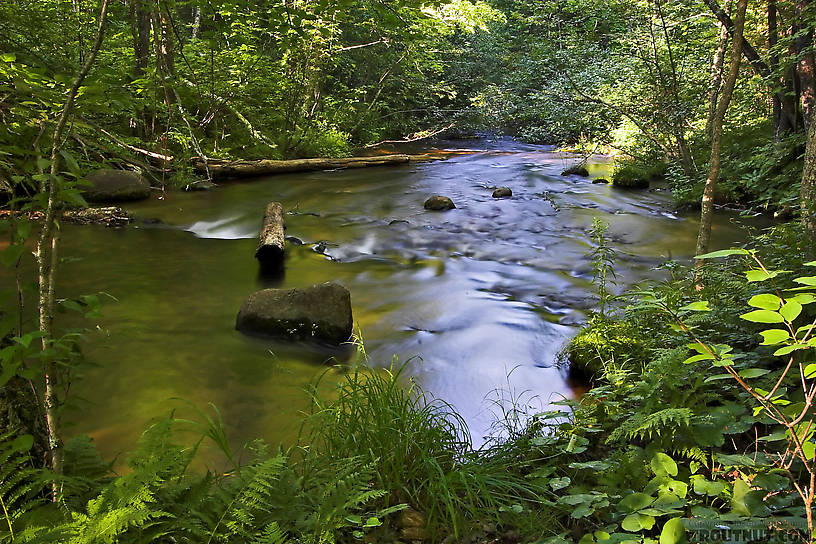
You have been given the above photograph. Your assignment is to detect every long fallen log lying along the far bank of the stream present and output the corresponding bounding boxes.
[194,155,411,178]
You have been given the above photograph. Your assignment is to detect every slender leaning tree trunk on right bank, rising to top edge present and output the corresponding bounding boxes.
[697,0,748,262]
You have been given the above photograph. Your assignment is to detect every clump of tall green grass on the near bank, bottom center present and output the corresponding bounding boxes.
[303,360,544,537]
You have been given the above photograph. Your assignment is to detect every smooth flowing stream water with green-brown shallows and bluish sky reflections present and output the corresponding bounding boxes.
[3,141,764,456]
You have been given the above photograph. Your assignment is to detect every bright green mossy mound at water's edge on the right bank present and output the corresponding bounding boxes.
[563,316,648,379]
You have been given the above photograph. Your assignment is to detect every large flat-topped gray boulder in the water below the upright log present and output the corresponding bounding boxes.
[235,283,353,344]
